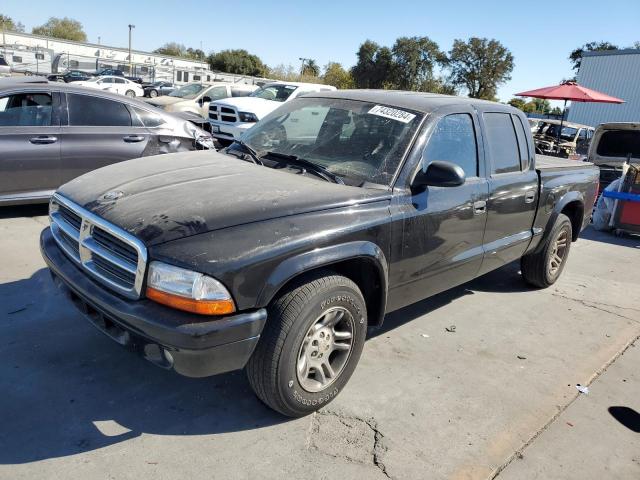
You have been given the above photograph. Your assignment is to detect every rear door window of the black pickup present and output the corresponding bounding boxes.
[483,113,520,173]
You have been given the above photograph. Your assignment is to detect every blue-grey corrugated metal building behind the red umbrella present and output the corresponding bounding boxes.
[568,49,640,127]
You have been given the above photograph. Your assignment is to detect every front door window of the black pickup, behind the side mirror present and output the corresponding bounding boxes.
[423,113,478,177]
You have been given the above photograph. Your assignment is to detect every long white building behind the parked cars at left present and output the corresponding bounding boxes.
[0,32,264,85]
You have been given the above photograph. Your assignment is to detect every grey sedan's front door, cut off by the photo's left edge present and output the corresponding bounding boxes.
[0,90,60,199]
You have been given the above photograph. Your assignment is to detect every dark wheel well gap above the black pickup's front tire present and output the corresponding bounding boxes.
[273,258,385,327]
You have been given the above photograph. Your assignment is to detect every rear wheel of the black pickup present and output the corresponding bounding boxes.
[520,213,573,288]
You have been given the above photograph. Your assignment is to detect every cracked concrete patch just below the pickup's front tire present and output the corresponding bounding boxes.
[306,410,393,479]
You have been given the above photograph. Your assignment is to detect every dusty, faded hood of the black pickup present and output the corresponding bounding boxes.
[58,151,389,246]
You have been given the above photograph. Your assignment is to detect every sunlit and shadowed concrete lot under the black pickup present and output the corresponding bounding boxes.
[0,203,640,480]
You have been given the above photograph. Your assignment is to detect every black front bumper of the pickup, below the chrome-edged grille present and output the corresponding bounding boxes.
[40,228,267,377]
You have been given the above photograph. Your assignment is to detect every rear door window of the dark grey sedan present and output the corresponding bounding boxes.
[67,94,131,127]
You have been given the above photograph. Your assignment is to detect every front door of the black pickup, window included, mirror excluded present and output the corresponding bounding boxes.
[391,107,488,307]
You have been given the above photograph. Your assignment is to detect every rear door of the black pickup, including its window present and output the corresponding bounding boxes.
[481,110,538,274]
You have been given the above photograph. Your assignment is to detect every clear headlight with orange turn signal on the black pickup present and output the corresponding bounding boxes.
[146,261,236,315]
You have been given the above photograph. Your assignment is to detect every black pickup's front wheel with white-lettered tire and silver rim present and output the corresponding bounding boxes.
[247,270,367,417]
